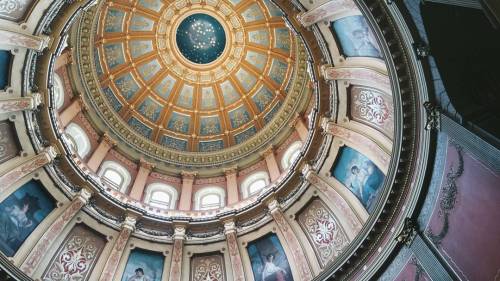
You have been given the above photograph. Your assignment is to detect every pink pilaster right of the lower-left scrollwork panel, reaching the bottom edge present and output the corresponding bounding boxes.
[99,216,137,281]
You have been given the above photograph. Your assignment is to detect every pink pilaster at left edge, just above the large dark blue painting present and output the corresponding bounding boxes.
[0,146,58,189]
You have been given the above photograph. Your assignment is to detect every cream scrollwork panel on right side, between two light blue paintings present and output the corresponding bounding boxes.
[349,86,394,138]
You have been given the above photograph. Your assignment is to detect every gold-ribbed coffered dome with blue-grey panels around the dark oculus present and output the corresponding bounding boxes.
[94,0,296,152]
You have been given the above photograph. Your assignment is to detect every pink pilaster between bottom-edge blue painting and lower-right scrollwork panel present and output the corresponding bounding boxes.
[268,200,313,281]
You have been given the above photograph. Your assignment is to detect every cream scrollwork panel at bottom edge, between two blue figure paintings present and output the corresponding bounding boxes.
[191,254,226,281]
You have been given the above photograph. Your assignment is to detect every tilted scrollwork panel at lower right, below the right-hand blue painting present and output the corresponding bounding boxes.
[298,199,349,267]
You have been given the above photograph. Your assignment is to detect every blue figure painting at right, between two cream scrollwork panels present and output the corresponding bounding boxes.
[332,146,384,212]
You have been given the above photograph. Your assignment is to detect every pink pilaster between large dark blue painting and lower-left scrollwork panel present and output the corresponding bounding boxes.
[21,189,92,276]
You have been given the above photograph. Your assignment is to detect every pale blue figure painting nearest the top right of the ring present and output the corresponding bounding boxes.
[332,16,382,58]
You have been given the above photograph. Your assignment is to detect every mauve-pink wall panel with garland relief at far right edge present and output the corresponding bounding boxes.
[426,144,500,280]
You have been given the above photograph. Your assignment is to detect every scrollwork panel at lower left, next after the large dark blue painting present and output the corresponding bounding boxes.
[42,222,106,281]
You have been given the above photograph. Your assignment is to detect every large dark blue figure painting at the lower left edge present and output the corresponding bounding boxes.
[0,181,55,257]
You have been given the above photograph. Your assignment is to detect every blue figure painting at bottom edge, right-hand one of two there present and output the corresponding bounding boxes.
[248,234,293,281]
